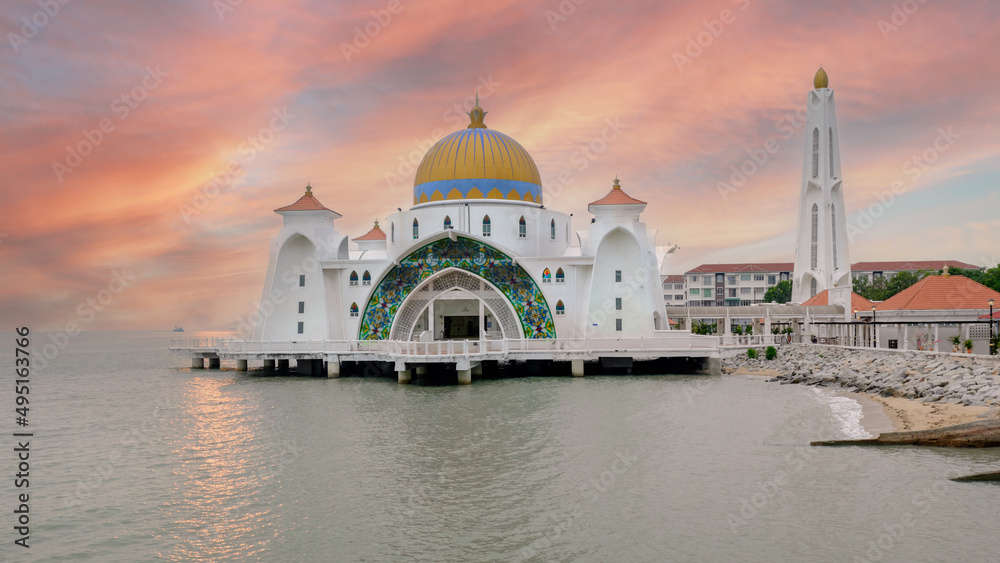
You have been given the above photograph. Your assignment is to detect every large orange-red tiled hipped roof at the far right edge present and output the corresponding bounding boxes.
[876,276,1000,311]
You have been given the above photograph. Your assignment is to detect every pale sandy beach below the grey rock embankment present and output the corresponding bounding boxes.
[724,368,1000,436]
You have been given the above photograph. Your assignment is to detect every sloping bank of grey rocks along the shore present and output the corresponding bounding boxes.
[723,345,1000,406]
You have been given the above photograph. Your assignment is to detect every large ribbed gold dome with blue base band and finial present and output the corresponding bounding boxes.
[413,96,542,205]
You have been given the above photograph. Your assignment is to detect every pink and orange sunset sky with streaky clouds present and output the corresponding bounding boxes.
[0,0,1000,330]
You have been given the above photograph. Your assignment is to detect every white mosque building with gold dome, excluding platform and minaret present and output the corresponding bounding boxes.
[253,97,680,354]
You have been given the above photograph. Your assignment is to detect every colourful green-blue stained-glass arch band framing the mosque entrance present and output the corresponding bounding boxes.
[358,237,556,340]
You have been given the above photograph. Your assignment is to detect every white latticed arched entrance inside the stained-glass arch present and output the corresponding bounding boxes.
[391,268,523,340]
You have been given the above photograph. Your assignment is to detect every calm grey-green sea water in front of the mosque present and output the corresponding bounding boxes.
[0,333,1000,562]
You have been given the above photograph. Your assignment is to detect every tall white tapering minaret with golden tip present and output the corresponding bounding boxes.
[792,68,852,303]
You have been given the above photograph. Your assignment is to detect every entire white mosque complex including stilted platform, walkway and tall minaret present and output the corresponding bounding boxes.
[175,69,851,383]
